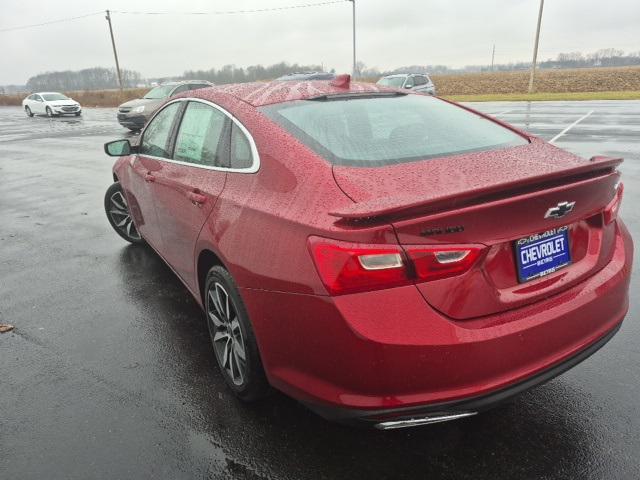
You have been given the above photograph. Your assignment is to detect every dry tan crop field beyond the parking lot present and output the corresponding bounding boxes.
[5,67,640,107]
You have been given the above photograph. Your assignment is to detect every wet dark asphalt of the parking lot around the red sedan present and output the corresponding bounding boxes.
[0,101,640,480]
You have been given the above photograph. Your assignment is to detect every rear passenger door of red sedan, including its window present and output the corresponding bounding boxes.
[152,100,230,289]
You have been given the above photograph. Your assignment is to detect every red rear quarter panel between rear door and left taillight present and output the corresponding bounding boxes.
[195,98,397,295]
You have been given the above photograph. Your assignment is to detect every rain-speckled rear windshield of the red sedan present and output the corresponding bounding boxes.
[261,95,528,167]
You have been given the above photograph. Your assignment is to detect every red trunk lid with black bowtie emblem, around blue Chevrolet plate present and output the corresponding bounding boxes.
[332,139,621,320]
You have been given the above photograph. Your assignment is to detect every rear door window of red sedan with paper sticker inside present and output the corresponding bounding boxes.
[173,102,227,167]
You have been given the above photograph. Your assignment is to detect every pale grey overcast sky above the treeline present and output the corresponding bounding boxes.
[0,0,640,84]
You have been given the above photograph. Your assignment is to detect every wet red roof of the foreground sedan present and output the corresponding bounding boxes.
[191,80,397,107]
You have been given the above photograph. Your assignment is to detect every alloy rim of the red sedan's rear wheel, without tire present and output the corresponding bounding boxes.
[207,282,247,386]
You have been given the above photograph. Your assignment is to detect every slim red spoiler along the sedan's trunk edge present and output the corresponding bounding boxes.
[329,156,623,221]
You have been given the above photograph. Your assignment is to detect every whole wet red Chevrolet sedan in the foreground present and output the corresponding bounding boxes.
[105,76,633,429]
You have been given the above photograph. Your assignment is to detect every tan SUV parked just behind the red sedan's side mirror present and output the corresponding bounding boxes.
[118,80,213,131]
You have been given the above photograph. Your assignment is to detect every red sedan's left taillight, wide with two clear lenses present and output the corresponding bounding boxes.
[309,237,482,295]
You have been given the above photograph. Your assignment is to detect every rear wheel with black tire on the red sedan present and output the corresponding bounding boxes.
[204,265,270,402]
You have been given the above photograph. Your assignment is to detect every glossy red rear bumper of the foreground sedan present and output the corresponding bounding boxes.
[241,222,633,422]
